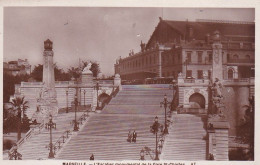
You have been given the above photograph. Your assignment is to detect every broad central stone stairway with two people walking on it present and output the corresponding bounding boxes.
[56,84,173,160]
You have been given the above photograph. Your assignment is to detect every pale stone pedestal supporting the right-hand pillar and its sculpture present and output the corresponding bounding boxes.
[208,120,230,161]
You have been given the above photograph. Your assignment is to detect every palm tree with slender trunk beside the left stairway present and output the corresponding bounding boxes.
[11,97,28,141]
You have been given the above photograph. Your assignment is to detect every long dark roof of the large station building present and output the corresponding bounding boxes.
[164,20,255,39]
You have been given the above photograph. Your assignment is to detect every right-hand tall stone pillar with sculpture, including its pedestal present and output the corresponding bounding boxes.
[208,31,230,161]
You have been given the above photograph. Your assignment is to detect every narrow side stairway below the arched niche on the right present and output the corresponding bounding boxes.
[161,114,206,160]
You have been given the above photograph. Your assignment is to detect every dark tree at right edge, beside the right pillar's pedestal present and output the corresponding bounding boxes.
[238,96,255,160]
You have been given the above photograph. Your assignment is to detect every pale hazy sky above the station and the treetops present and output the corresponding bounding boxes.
[3,7,255,75]
